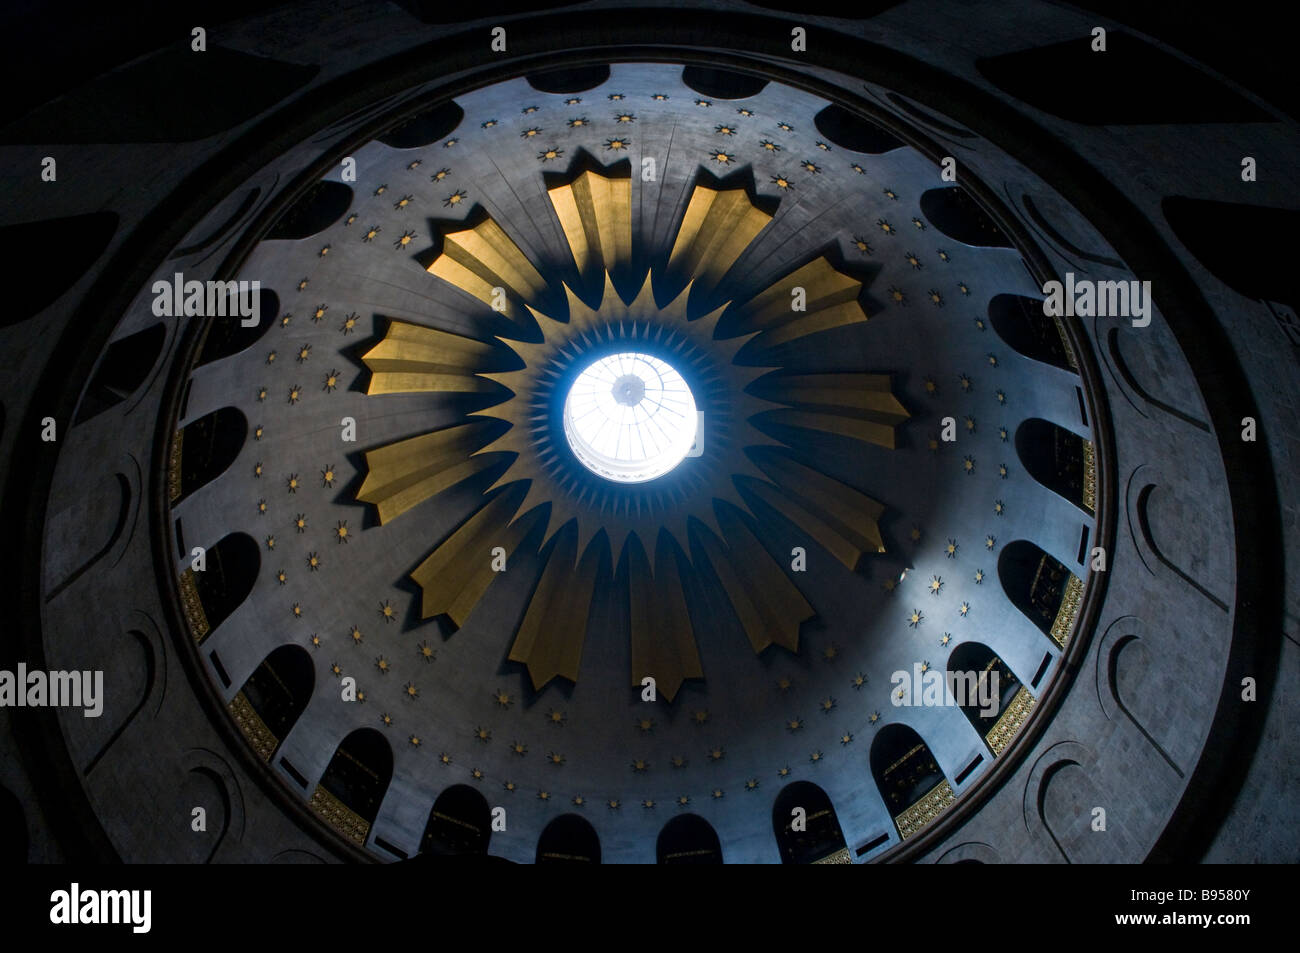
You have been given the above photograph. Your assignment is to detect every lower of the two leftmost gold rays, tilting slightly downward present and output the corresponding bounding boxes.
[356,421,502,525]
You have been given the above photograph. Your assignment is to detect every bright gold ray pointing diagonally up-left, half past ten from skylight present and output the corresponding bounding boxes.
[428,218,546,326]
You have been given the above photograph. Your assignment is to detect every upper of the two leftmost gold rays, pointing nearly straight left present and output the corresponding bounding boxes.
[361,321,495,394]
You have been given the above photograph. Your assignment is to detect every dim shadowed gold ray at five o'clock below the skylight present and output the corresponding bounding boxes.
[699,507,816,655]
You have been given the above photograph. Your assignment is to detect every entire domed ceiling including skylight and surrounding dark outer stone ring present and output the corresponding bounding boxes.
[0,0,1300,865]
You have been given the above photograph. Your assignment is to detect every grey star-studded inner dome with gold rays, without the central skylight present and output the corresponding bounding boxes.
[159,62,1096,861]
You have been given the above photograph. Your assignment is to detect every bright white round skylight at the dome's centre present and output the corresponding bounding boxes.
[564,352,697,484]
